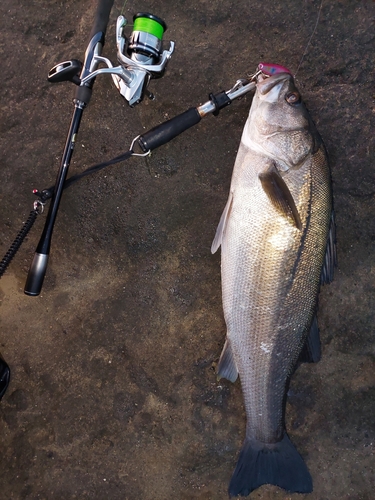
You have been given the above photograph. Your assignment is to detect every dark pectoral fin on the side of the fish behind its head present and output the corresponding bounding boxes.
[259,166,302,230]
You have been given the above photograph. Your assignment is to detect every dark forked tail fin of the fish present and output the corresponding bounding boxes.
[228,433,313,497]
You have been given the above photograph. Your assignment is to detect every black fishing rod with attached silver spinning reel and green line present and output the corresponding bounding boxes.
[24,0,174,296]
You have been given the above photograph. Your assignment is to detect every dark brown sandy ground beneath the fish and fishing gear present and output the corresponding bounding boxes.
[0,0,375,500]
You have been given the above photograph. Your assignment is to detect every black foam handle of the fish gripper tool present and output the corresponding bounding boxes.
[138,108,201,153]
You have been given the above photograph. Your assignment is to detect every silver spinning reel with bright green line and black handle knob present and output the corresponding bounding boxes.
[48,12,175,107]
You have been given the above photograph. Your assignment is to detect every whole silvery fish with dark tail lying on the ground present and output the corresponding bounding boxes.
[211,70,336,497]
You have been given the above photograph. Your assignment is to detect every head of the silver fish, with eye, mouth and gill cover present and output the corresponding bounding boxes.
[242,73,321,171]
